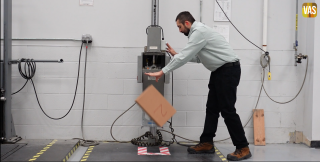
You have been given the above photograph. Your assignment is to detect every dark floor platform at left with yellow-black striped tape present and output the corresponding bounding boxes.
[1,140,80,161]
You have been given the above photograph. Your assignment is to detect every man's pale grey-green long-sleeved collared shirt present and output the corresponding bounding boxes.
[162,21,239,74]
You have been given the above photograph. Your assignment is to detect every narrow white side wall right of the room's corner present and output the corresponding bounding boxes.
[299,0,320,141]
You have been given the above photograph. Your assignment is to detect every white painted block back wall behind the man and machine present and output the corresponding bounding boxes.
[0,0,307,143]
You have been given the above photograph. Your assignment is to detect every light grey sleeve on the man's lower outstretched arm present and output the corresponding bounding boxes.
[162,30,207,74]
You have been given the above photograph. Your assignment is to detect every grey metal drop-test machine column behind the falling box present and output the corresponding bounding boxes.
[137,0,170,144]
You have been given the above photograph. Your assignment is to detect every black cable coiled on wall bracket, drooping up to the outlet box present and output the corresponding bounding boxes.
[18,43,83,120]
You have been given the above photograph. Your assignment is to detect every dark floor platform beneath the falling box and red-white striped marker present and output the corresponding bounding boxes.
[81,142,227,162]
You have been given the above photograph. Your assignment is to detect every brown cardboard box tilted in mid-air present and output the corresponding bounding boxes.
[136,85,177,127]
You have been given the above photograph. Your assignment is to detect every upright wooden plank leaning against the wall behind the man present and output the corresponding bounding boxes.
[253,109,266,146]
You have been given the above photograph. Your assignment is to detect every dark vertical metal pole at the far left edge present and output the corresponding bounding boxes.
[3,0,15,140]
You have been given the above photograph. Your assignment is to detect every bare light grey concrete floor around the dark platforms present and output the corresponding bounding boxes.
[68,143,320,161]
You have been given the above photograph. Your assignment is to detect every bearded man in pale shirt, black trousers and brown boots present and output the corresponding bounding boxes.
[146,11,251,160]
